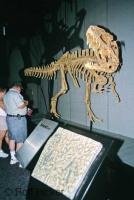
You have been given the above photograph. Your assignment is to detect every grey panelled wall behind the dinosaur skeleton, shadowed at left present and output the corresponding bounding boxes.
[0,0,134,138]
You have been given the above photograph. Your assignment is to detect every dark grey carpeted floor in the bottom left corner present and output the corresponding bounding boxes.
[0,149,30,200]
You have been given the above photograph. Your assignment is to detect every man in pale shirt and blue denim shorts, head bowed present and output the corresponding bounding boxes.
[4,83,28,165]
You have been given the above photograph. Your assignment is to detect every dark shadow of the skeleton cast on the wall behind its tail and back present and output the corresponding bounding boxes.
[14,1,86,114]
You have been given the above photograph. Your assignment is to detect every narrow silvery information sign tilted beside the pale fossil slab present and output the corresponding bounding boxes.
[16,118,58,168]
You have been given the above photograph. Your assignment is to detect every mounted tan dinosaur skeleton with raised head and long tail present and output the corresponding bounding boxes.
[24,26,121,122]
